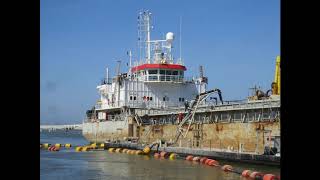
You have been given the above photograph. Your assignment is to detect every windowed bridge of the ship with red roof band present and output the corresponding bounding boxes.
[131,64,187,83]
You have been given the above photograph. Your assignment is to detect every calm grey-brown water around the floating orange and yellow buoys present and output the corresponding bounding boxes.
[40,131,280,180]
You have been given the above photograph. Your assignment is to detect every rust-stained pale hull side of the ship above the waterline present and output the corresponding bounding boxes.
[83,121,280,154]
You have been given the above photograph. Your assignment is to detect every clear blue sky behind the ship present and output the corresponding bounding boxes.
[40,0,280,124]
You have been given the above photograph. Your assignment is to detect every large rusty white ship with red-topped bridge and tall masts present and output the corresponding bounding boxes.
[82,11,281,156]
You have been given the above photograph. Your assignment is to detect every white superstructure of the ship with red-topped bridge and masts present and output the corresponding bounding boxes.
[95,11,207,119]
